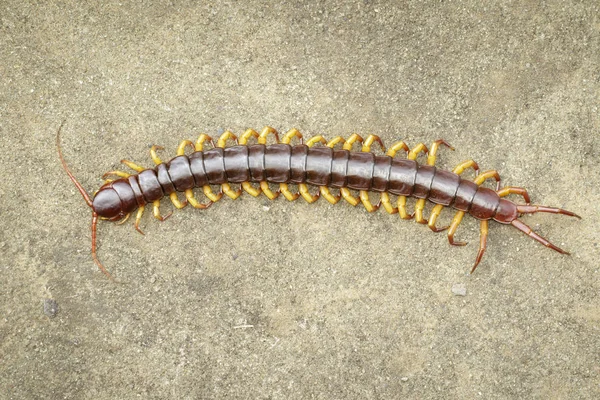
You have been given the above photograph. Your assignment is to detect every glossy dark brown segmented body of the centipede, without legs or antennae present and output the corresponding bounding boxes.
[93,143,508,220]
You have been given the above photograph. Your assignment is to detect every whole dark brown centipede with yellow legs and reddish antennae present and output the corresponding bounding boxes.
[56,121,581,280]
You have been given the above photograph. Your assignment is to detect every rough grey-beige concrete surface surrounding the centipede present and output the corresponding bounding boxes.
[0,0,600,399]
